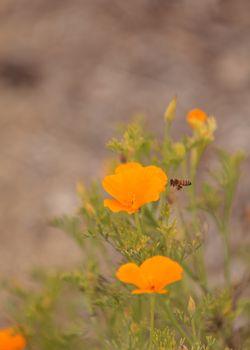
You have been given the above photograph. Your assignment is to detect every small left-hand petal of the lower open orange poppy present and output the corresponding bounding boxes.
[116,263,148,289]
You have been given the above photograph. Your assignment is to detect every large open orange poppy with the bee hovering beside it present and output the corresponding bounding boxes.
[102,163,167,214]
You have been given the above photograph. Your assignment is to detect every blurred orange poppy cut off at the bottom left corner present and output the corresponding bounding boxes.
[0,328,26,350]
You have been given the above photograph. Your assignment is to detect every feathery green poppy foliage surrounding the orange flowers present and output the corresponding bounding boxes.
[2,100,250,350]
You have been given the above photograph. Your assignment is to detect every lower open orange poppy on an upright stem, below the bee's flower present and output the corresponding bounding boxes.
[116,256,183,294]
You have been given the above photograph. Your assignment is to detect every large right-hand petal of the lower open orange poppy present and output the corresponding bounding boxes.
[140,256,183,291]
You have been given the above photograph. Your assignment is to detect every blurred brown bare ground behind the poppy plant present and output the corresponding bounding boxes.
[0,0,250,288]
